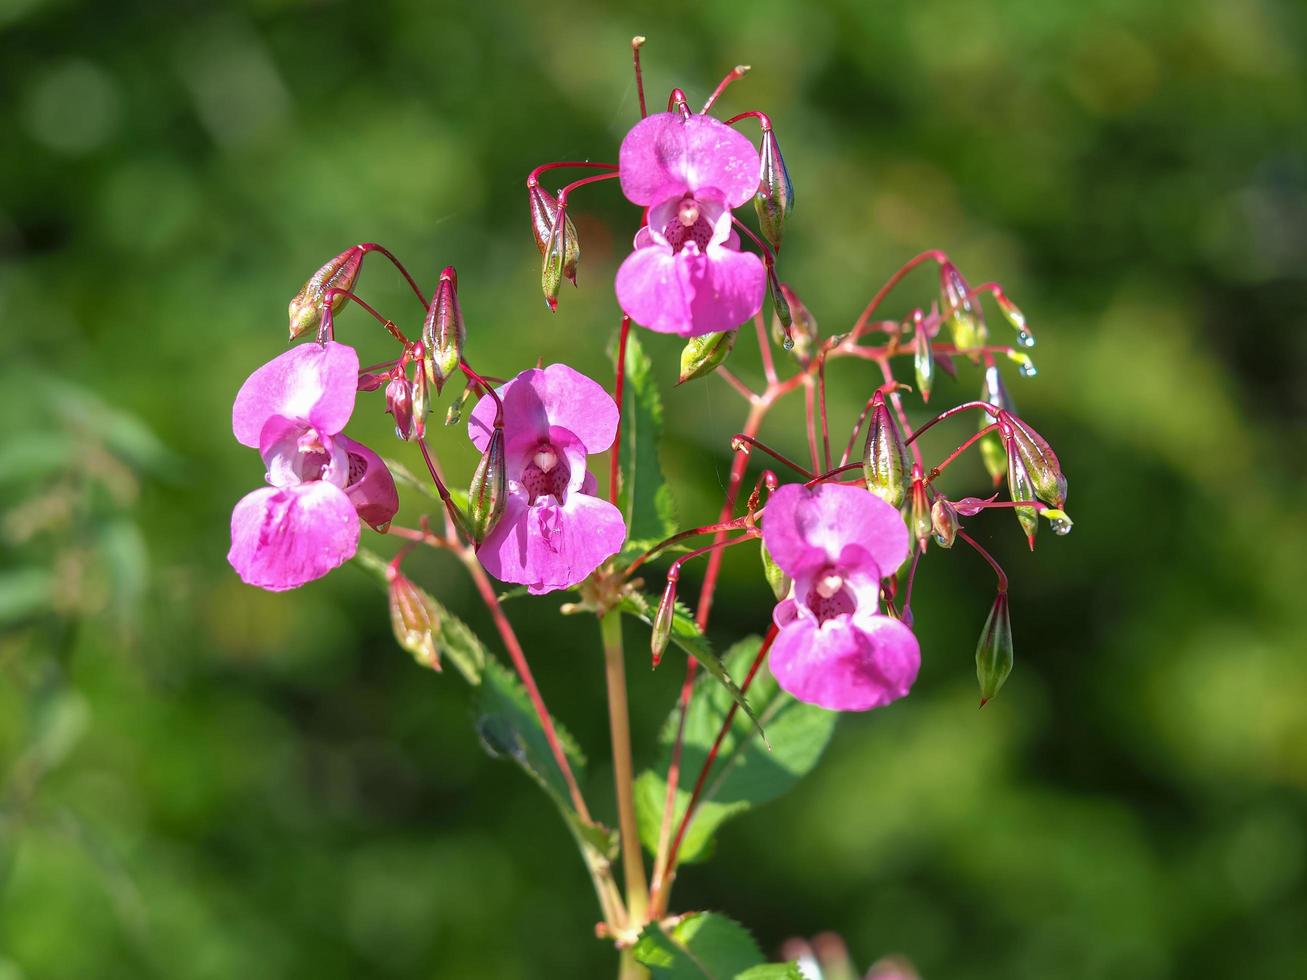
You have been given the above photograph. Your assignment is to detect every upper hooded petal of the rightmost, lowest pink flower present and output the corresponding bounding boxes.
[762,483,908,579]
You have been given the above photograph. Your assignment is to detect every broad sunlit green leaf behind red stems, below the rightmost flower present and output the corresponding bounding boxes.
[635,636,839,864]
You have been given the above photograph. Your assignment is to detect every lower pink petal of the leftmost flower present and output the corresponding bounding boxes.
[227,481,358,592]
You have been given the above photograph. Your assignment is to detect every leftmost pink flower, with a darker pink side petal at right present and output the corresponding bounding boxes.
[227,341,399,592]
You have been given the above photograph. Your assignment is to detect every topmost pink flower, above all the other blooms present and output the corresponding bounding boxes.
[617,112,766,337]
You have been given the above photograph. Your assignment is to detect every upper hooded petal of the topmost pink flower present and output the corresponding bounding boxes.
[618,112,762,208]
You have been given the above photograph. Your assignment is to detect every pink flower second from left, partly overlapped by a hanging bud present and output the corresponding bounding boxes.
[468,365,626,595]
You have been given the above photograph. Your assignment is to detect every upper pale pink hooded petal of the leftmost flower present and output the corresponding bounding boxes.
[231,341,358,449]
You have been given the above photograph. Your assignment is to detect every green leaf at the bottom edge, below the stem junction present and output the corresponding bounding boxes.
[633,912,762,980]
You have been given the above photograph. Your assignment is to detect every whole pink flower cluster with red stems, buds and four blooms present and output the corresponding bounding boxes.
[229,38,1072,976]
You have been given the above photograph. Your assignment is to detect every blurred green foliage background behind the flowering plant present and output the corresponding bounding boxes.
[0,0,1307,980]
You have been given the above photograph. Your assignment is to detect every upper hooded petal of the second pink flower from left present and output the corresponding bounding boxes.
[468,365,617,453]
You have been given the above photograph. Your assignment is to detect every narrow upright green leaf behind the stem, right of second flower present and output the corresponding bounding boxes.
[617,331,677,555]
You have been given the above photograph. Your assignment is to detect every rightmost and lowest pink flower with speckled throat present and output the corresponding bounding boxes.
[762,483,921,711]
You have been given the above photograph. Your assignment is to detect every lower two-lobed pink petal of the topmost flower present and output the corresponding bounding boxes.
[616,246,767,337]
